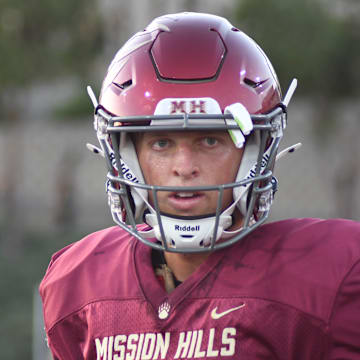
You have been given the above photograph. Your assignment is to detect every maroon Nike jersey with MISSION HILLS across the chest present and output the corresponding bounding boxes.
[40,219,360,360]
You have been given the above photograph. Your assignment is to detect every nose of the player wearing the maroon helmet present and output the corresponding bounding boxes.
[172,144,200,180]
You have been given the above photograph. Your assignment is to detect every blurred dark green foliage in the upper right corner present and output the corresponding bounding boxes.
[235,0,360,99]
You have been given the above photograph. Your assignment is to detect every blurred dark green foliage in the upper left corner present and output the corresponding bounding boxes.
[0,0,103,121]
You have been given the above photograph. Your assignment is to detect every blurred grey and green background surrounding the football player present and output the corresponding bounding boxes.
[0,0,360,360]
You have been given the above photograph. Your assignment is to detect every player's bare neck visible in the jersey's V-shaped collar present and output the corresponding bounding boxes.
[165,252,210,282]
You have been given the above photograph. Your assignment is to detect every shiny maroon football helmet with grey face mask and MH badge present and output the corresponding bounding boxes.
[89,13,294,252]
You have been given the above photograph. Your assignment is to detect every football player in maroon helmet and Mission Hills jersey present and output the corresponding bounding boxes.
[40,13,360,360]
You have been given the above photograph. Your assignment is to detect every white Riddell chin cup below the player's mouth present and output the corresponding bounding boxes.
[145,214,232,249]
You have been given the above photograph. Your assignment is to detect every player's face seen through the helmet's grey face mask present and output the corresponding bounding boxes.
[135,132,243,216]
